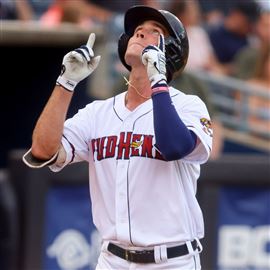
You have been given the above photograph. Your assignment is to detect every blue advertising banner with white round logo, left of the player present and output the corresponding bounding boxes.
[43,185,101,270]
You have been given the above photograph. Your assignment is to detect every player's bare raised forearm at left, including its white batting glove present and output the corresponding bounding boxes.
[27,33,100,163]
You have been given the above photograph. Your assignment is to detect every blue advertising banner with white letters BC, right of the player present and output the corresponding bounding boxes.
[217,187,270,270]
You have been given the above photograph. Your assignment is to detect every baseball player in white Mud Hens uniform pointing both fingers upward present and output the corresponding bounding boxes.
[23,6,212,270]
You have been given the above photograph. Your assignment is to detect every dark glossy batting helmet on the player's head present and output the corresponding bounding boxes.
[118,6,189,82]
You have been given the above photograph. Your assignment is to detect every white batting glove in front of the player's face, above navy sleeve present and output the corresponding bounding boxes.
[142,34,167,90]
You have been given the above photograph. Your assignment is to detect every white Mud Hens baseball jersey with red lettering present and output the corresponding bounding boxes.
[51,87,212,247]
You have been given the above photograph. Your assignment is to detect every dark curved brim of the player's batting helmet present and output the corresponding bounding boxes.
[124,6,174,37]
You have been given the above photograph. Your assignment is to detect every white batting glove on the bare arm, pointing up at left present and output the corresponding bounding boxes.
[56,33,100,91]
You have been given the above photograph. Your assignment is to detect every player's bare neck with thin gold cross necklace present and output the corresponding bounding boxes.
[125,69,152,110]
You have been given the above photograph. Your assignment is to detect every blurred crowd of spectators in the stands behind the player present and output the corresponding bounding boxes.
[0,0,270,157]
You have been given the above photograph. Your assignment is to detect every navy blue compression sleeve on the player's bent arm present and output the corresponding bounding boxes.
[152,92,197,161]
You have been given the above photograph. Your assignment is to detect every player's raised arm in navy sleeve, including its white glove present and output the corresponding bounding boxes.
[142,34,199,161]
